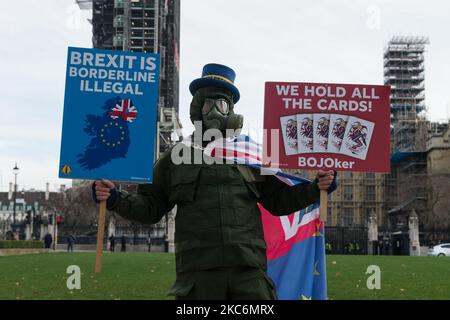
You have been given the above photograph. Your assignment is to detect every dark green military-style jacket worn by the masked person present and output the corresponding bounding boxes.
[108,145,320,274]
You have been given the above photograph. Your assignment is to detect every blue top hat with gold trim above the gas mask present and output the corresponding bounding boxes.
[189,63,240,103]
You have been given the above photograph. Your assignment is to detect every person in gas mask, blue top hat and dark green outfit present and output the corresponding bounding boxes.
[93,64,336,299]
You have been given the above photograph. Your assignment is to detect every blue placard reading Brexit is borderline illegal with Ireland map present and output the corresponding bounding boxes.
[59,47,159,183]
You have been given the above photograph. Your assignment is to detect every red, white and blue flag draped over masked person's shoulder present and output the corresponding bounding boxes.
[205,135,327,300]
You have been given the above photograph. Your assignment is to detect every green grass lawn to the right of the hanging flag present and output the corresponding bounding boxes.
[327,256,450,300]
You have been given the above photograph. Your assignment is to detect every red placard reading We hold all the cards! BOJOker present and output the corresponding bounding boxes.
[263,82,390,172]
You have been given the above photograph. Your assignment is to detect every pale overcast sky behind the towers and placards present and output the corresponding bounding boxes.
[0,0,450,191]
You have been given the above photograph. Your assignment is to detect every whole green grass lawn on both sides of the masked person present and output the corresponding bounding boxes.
[0,252,450,300]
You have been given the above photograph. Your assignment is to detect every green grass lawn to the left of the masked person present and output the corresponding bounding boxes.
[0,252,175,300]
